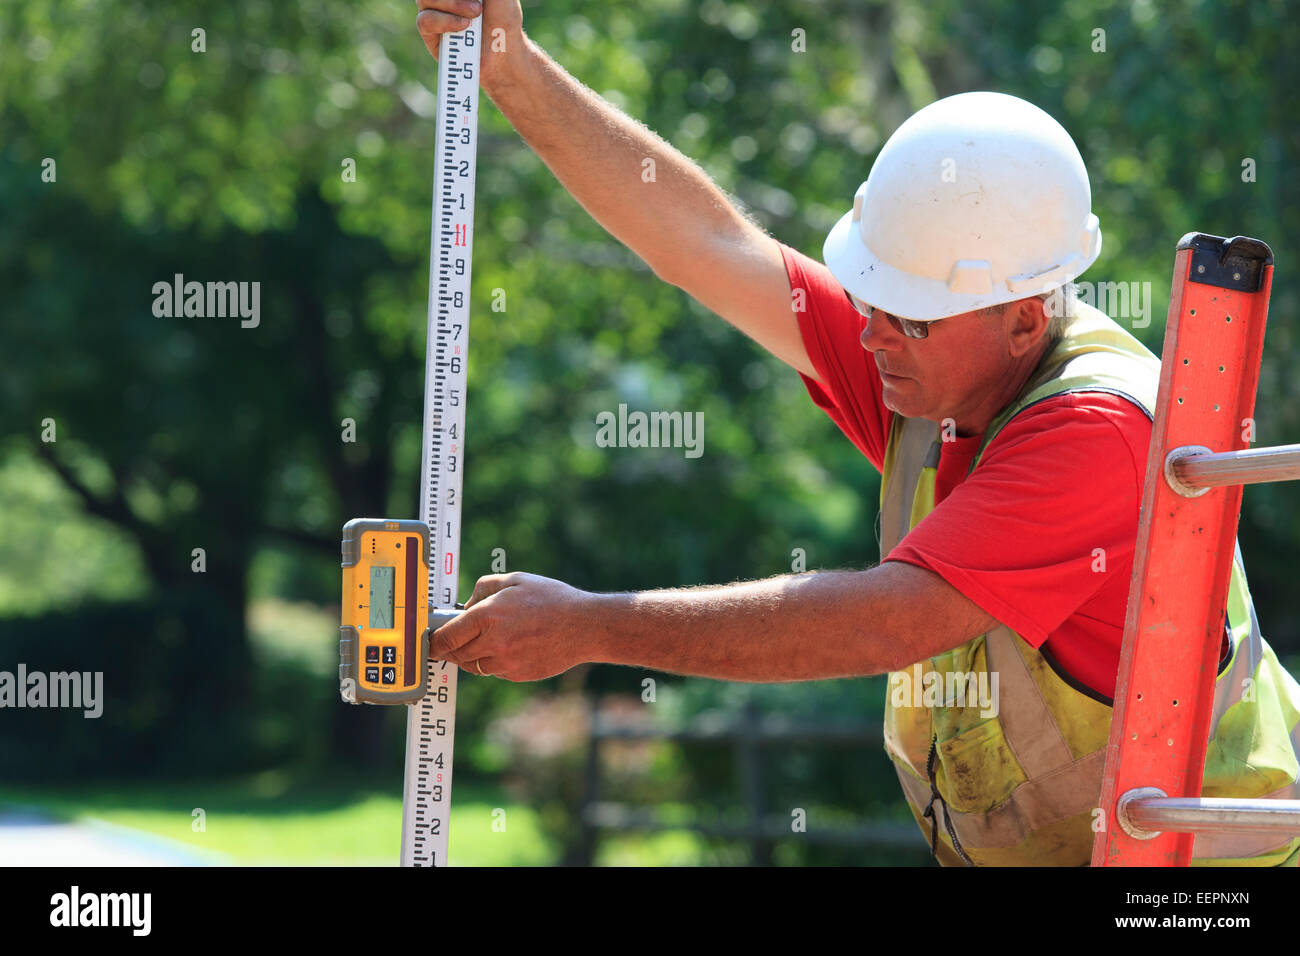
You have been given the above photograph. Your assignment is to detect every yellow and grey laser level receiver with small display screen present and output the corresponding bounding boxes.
[338,518,456,704]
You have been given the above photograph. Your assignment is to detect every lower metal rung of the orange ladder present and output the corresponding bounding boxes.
[1119,795,1300,838]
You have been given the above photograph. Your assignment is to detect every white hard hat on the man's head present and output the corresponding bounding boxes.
[822,92,1101,321]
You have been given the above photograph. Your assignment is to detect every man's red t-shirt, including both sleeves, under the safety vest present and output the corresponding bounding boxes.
[781,245,1151,698]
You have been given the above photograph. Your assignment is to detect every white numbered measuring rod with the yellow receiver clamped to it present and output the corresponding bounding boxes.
[339,20,482,866]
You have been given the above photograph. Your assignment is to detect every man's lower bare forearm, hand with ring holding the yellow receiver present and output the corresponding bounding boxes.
[430,561,997,683]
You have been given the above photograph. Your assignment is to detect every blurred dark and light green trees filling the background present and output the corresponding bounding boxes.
[0,0,1300,862]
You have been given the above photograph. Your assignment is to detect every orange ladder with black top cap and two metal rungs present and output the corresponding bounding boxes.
[1092,233,1300,866]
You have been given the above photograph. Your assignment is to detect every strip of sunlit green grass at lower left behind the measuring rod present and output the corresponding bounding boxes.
[0,773,556,866]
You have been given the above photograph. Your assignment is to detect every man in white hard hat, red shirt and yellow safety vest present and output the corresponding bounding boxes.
[416,0,1300,865]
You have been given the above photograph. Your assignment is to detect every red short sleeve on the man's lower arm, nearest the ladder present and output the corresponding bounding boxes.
[885,393,1151,646]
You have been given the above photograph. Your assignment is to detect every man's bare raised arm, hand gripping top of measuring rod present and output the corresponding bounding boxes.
[416,0,816,378]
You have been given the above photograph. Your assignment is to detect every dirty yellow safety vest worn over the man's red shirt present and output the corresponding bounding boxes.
[880,302,1300,866]
